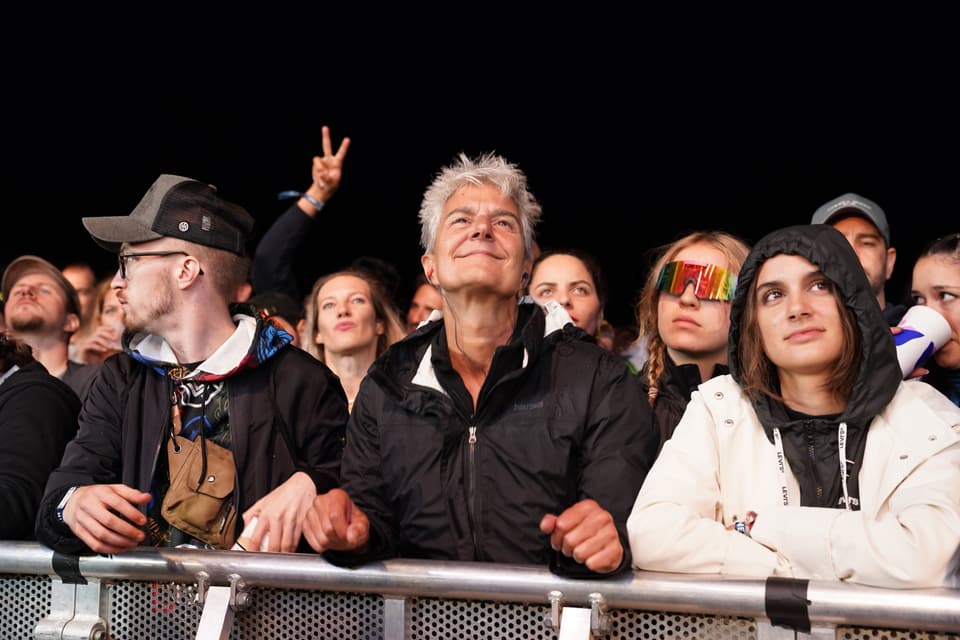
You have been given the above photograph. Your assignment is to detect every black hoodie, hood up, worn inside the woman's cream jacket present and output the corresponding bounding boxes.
[729,224,901,509]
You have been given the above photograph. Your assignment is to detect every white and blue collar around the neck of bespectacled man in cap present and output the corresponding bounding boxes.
[123,312,293,382]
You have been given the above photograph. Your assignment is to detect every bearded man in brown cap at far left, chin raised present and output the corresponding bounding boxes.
[2,255,99,402]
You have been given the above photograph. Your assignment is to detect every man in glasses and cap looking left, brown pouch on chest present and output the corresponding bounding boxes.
[36,175,347,553]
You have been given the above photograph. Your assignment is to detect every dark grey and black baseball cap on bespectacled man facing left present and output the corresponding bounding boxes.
[83,174,253,255]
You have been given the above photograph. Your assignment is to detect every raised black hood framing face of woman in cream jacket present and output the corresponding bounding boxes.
[728,224,901,431]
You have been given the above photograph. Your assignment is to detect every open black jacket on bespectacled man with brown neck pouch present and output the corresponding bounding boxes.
[36,328,347,553]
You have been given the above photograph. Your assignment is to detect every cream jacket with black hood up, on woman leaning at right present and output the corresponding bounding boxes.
[627,225,960,588]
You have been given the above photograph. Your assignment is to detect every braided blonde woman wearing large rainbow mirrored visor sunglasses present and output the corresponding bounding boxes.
[636,231,750,448]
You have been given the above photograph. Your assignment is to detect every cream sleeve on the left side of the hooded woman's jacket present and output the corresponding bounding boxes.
[627,391,790,576]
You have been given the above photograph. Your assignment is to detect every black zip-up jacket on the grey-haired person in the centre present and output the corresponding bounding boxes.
[327,304,658,576]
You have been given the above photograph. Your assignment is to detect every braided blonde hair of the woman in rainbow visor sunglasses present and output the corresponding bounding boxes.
[635,231,750,405]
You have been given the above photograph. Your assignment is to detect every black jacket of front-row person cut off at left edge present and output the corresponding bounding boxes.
[0,362,80,540]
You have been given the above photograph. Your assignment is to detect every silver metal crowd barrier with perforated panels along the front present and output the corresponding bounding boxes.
[0,542,960,640]
